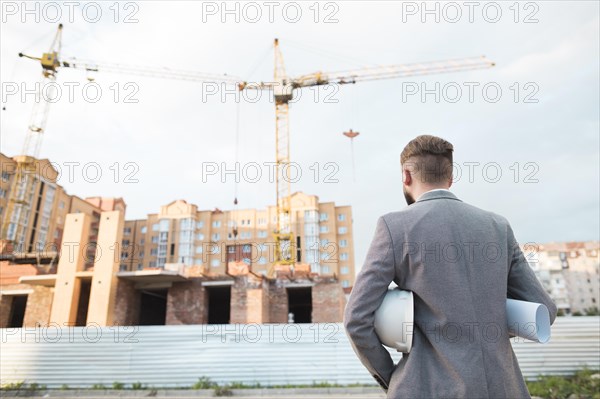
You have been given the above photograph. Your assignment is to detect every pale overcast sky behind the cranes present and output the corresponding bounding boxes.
[0,1,600,269]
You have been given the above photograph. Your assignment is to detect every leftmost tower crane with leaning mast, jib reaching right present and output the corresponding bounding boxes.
[0,24,240,252]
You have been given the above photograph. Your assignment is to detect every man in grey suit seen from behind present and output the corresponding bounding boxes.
[344,136,557,399]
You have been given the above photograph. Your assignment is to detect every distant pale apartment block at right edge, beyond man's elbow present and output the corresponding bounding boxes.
[523,241,600,314]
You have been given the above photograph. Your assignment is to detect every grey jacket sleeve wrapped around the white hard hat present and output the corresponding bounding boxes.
[344,217,395,390]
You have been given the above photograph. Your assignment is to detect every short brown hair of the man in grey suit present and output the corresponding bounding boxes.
[400,134,454,184]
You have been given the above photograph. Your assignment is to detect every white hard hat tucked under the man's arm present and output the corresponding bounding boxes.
[375,288,414,353]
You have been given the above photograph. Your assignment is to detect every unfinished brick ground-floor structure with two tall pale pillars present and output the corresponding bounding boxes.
[0,210,345,327]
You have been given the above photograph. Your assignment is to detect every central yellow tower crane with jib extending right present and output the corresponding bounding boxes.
[239,39,495,275]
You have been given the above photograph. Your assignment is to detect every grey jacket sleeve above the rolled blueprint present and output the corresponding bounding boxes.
[507,225,557,324]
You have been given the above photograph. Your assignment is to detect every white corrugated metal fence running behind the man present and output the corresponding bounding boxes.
[0,317,600,388]
